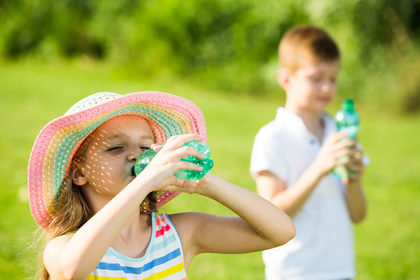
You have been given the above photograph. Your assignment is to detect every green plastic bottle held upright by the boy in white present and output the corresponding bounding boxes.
[334,99,360,180]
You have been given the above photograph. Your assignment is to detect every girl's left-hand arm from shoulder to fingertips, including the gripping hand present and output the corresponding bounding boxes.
[44,135,202,280]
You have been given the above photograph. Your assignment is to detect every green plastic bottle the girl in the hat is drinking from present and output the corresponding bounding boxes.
[131,140,214,181]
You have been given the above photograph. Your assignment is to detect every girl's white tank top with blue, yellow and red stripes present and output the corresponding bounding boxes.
[69,213,187,280]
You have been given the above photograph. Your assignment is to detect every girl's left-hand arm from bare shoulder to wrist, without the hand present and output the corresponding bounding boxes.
[44,176,156,279]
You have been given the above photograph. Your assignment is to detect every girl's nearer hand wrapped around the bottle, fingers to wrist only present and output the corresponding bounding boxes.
[135,134,204,192]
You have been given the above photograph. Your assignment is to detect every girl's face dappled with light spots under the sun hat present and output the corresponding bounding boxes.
[73,116,155,198]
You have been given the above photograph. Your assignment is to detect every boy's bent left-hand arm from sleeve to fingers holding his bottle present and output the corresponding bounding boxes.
[256,132,355,217]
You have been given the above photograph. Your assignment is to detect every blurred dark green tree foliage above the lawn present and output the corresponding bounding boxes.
[0,0,420,110]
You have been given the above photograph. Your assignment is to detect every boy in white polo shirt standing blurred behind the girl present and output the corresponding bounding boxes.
[251,25,366,280]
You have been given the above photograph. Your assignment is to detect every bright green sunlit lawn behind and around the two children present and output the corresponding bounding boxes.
[0,59,420,280]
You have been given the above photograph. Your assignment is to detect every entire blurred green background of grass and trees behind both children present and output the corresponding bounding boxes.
[0,0,420,279]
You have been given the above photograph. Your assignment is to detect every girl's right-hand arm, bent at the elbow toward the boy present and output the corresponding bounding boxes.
[171,174,296,266]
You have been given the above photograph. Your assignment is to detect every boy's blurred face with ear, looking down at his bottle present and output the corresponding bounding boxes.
[279,61,340,113]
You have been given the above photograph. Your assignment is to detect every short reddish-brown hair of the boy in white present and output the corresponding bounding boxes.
[279,25,340,71]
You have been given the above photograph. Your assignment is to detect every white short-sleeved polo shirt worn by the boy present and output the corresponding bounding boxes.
[251,108,355,280]
